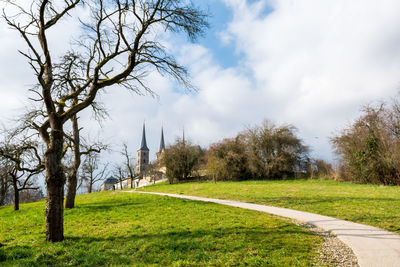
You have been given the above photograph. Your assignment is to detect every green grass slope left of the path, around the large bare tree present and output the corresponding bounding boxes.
[0,192,323,266]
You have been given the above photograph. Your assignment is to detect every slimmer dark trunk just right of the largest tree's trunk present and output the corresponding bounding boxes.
[65,115,81,209]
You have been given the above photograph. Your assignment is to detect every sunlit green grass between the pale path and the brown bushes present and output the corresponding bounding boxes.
[144,180,400,233]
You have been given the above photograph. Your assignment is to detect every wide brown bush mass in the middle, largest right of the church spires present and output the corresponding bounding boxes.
[207,121,309,180]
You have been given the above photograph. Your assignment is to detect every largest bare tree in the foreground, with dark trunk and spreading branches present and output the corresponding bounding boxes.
[3,0,207,242]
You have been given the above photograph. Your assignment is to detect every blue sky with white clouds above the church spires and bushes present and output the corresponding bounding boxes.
[0,0,400,165]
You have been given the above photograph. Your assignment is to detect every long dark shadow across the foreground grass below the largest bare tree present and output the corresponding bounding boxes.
[0,225,315,266]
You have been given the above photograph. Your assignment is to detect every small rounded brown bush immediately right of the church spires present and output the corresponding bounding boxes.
[163,139,204,184]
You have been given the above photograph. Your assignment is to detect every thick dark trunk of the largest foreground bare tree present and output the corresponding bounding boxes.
[45,127,65,242]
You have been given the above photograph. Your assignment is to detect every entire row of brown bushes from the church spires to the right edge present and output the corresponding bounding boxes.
[163,99,400,188]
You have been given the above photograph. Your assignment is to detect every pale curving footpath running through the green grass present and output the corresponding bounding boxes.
[134,191,400,267]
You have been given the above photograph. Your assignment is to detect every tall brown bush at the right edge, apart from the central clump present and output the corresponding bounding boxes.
[332,102,400,185]
